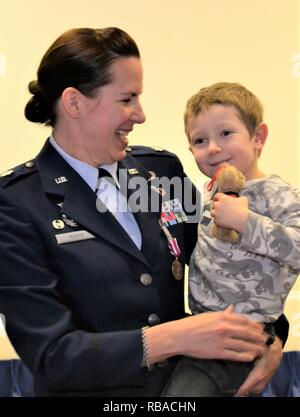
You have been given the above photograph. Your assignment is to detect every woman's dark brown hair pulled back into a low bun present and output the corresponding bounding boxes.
[25,27,140,126]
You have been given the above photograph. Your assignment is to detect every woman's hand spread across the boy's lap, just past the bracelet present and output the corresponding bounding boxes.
[146,306,267,363]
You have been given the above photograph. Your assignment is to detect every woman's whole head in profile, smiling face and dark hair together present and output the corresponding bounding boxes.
[25,28,145,166]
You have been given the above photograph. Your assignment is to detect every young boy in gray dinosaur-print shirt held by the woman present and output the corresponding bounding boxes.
[163,83,300,397]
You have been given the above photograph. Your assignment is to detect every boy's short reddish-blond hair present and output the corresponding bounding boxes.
[184,82,263,138]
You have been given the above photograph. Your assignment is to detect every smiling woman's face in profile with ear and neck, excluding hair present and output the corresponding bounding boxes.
[53,58,145,167]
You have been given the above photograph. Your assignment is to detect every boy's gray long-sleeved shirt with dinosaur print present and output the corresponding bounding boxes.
[189,175,300,323]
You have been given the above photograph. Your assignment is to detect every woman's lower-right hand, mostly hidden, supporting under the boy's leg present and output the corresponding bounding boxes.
[236,337,282,397]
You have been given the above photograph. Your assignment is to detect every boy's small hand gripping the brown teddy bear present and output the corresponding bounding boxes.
[211,193,249,233]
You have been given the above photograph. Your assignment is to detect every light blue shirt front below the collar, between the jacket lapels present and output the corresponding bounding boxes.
[95,168,142,249]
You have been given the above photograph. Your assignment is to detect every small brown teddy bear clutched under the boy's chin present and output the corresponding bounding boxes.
[211,165,246,243]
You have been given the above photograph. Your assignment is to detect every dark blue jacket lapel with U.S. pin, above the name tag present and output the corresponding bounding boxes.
[36,141,147,264]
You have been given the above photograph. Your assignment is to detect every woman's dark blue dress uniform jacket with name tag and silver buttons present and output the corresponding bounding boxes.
[0,141,197,396]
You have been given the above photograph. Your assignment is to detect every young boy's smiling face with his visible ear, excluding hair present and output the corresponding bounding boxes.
[186,104,267,180]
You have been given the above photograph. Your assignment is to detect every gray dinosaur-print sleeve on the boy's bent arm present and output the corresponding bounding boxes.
[240,186,300,272]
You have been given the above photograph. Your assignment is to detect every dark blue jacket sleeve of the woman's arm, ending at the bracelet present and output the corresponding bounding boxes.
[0,190,147,391]
